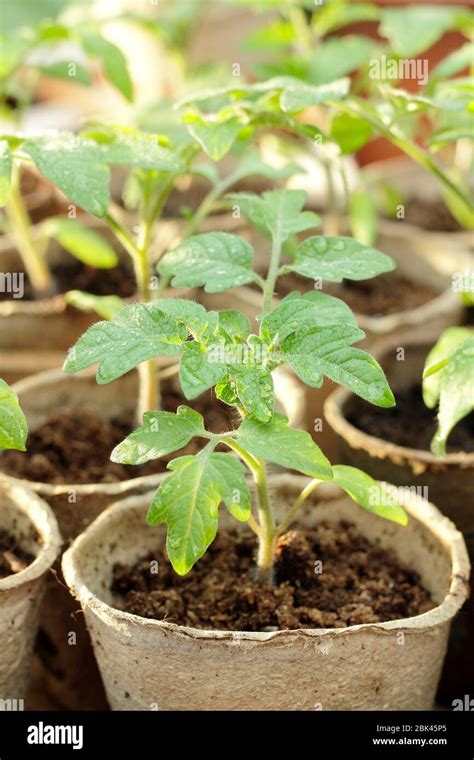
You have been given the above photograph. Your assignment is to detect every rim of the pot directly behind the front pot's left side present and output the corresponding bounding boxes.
[4,362,296,496]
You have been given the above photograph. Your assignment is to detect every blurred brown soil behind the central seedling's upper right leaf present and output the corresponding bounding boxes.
[277,272,438,317]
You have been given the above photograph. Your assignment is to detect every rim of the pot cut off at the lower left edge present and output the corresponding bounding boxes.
[0,475,62,599]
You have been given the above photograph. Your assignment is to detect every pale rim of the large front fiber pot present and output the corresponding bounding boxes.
[62,473,470,642]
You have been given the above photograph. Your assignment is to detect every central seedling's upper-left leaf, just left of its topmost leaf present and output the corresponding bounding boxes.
[158,232,257,293]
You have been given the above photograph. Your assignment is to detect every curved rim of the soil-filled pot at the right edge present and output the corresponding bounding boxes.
[324,336,474,469]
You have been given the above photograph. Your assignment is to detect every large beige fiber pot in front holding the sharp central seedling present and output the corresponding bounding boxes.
[63,474,469,710]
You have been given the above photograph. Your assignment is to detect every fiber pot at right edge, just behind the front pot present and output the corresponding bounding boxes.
[325,340,474,700]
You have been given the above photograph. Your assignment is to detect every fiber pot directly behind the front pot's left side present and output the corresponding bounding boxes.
[0,362,302,710]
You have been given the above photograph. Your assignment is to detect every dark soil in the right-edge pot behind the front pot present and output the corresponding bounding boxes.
[347,386,474,453]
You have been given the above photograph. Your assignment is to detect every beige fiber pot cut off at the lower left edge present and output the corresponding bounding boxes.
[0,478,61,700]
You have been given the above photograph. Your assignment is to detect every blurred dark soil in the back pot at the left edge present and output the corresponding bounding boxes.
[0,261,135,301]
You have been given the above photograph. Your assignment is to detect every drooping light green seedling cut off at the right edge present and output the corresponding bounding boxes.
[422,327,474,458]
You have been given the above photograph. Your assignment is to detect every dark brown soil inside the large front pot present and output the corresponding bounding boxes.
[111,522,435,631]
